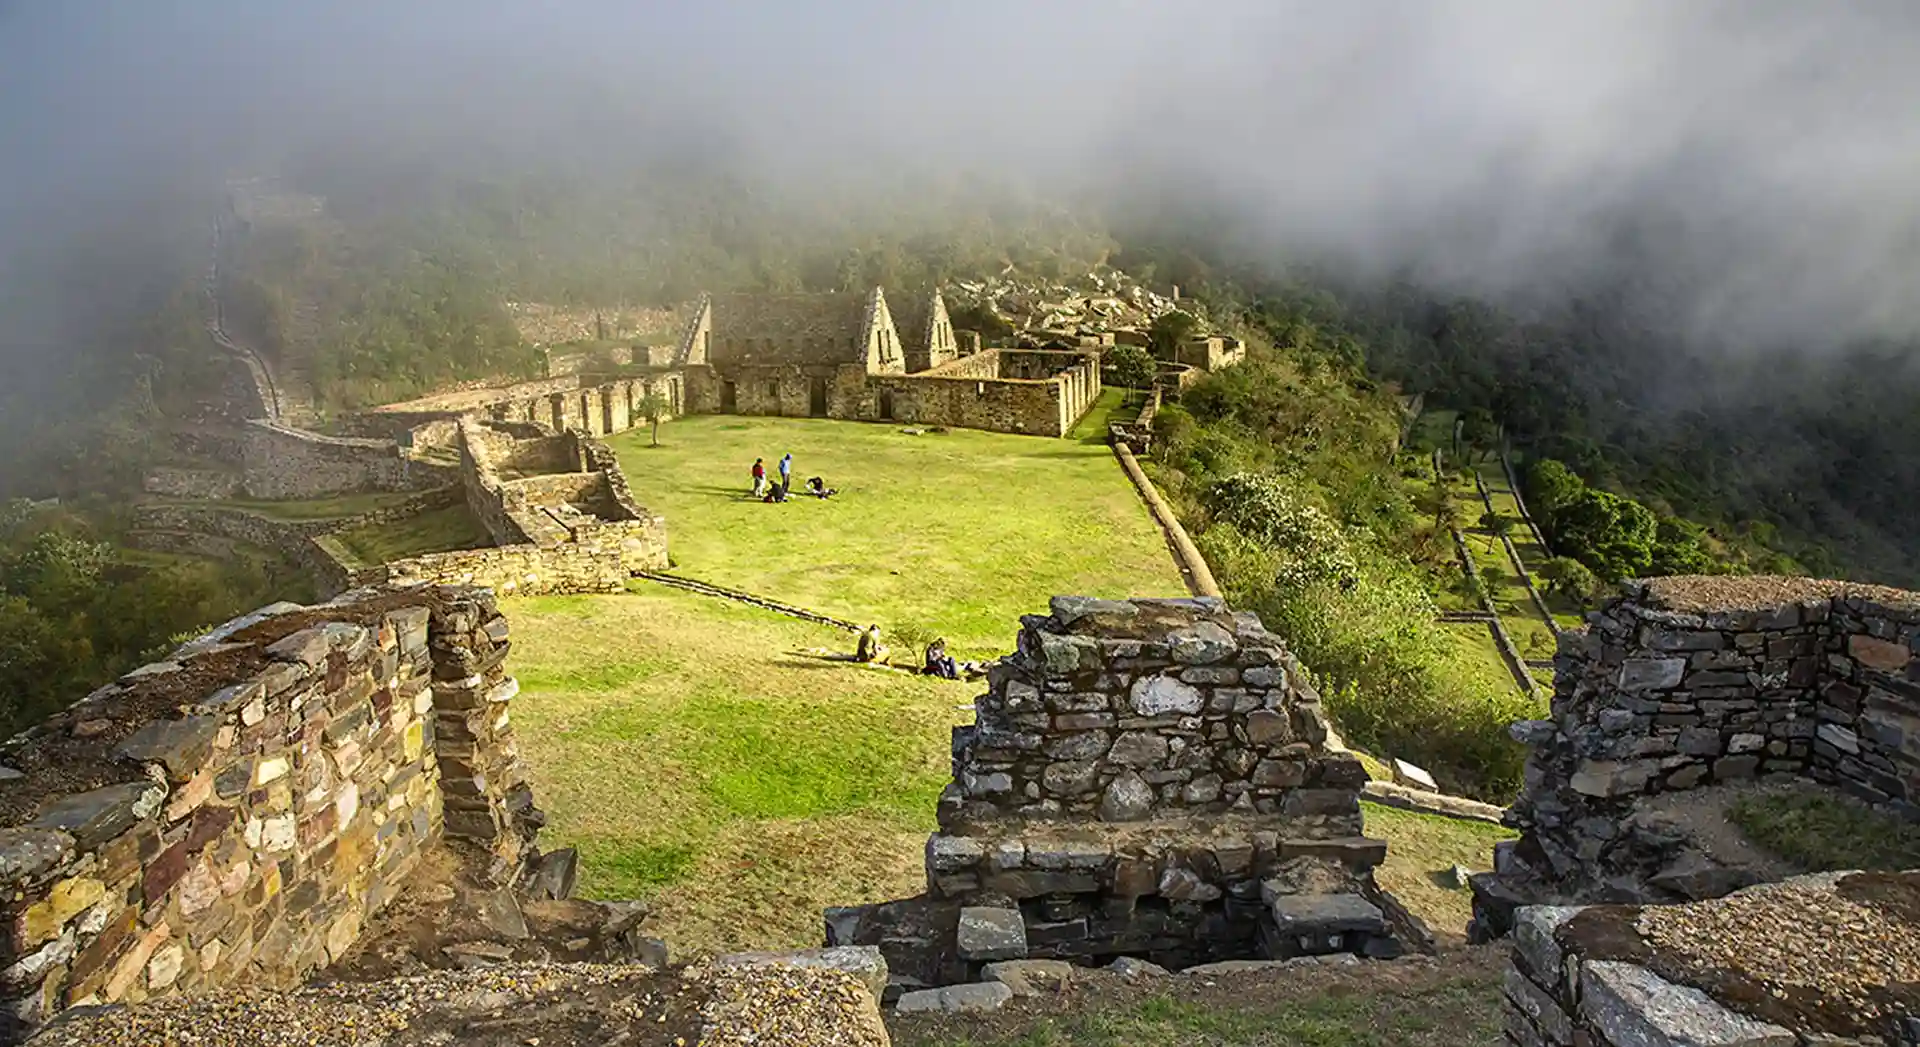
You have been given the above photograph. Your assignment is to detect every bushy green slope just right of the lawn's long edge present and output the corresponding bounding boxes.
[1150,311,1538,799]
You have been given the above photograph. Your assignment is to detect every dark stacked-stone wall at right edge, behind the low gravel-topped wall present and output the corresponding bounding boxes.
[1475,578,1920,934]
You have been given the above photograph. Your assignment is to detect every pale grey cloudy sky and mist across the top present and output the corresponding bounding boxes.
[0,0,1920,359]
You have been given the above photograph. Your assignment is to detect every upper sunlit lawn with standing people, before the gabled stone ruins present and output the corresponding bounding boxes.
[611,415,1187,657]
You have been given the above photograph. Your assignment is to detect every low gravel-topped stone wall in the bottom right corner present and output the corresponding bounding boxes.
[1503,872,1920,1047]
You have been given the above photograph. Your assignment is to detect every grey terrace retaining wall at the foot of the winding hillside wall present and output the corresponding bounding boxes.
[244,421,459,499]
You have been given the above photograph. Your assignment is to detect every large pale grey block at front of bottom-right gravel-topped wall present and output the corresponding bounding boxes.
[1580,961,1799,1047]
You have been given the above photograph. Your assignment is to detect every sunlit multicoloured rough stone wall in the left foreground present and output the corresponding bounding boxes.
[0,588,532,1035]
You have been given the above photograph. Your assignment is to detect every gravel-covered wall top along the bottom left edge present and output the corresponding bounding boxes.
[33,964,887,1047]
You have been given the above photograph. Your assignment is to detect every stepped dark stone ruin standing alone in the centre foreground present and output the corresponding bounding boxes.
[828,597,1432,991]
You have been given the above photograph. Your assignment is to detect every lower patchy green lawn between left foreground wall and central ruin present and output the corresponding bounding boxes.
[505,582,975,955]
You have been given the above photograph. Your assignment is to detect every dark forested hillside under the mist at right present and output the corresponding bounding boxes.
[1119,221,1920,586]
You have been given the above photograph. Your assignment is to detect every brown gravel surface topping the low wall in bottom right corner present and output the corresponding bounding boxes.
[1634,874,1920,1034]
